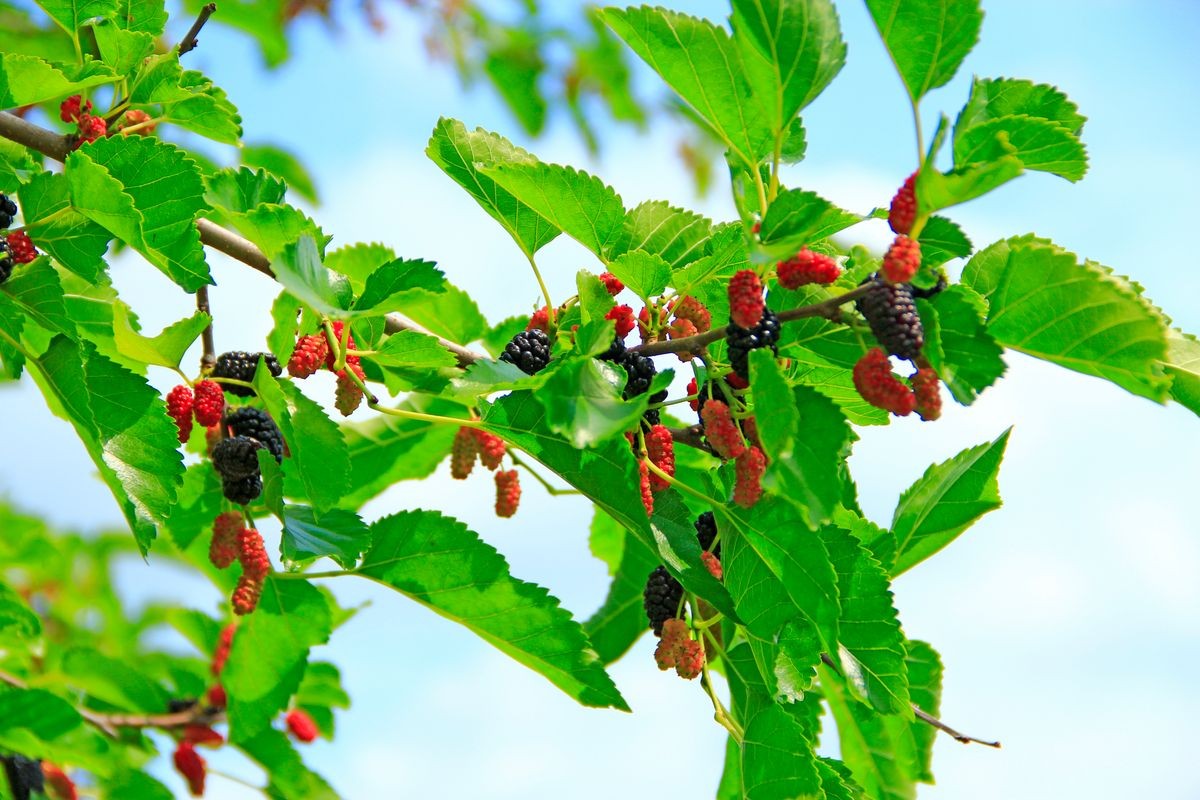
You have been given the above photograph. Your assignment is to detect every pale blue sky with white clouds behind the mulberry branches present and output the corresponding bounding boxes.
[0,0,1200,800]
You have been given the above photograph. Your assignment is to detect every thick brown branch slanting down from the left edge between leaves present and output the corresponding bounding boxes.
[0,112,487,367]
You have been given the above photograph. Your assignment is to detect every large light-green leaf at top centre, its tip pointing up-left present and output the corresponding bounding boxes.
[600,6,773,169]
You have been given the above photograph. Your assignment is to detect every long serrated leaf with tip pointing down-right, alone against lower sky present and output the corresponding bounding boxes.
[358,511,629,710]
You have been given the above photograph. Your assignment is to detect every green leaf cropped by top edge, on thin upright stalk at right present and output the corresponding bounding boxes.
[866,0,983,104]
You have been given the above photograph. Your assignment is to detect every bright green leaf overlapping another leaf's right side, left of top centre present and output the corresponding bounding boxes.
[481,162,625,260]
